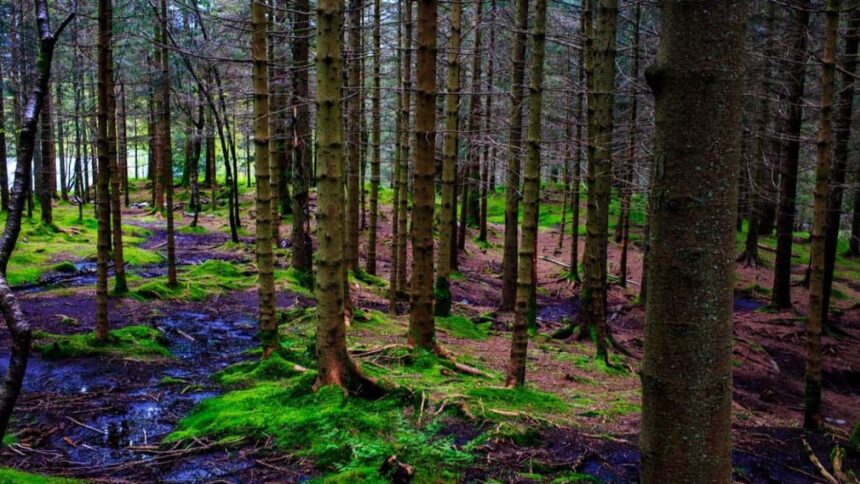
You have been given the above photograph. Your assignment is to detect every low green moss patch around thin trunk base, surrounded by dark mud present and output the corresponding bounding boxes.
[33,326,170,358]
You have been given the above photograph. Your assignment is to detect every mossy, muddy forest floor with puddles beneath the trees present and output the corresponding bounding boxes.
[0,185,860,482]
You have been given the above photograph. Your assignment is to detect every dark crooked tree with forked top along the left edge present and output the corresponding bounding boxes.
[0,0,71,448]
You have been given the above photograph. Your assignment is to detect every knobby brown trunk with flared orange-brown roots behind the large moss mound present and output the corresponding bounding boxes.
[314,0,378,394]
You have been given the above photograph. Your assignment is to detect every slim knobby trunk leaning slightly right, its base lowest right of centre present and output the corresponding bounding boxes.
[505,0,546,387]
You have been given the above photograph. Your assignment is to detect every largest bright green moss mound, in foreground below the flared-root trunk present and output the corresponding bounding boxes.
[166,372,472,482]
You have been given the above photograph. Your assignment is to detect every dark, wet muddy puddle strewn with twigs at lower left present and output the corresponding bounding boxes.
[0,300,295,482]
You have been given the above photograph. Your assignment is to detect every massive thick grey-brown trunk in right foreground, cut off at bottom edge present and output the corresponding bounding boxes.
[640,0,746,482]
